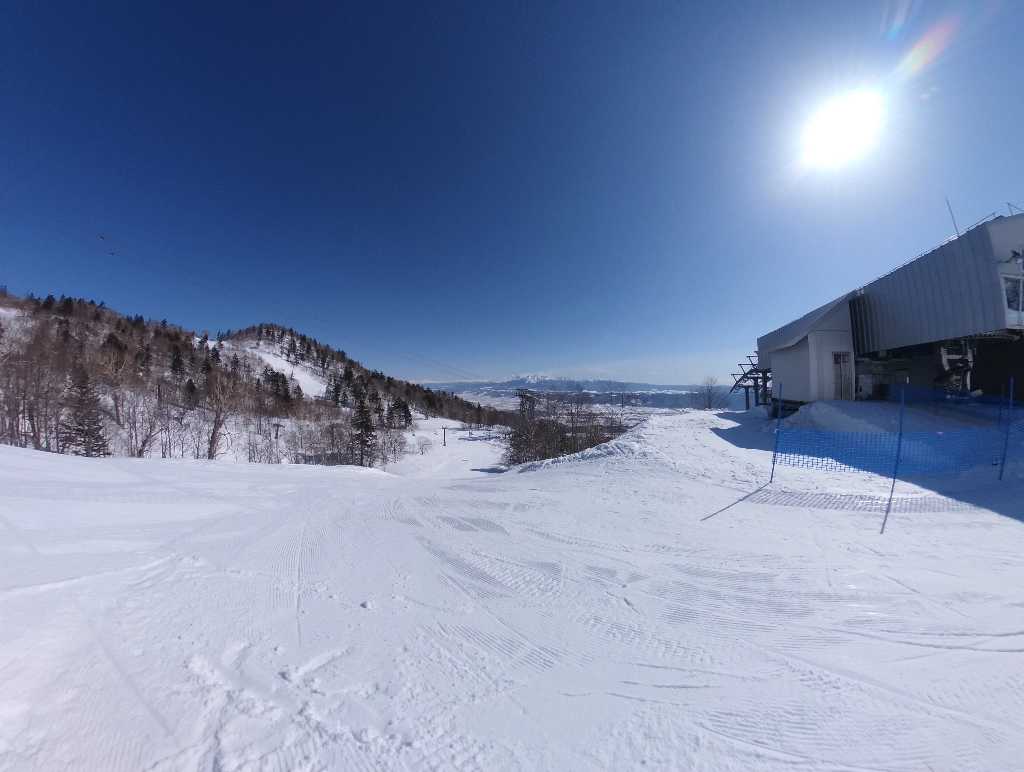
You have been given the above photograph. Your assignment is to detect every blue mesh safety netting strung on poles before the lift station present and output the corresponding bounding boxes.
[774,390,1024,477]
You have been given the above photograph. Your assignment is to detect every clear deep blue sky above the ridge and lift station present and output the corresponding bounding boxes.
[0,0,1024,383]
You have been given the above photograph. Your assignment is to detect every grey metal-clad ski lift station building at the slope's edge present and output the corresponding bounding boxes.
[753,214,1024,402]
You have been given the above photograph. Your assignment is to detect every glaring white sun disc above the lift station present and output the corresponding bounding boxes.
[801,89,886,169]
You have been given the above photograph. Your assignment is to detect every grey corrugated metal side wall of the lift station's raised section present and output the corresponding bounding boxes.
[850,219,1007,354]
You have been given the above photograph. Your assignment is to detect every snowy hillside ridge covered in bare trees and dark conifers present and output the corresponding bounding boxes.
[0,290,510,465]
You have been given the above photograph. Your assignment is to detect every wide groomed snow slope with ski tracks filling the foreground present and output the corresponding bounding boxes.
[0,413,1024,771]
